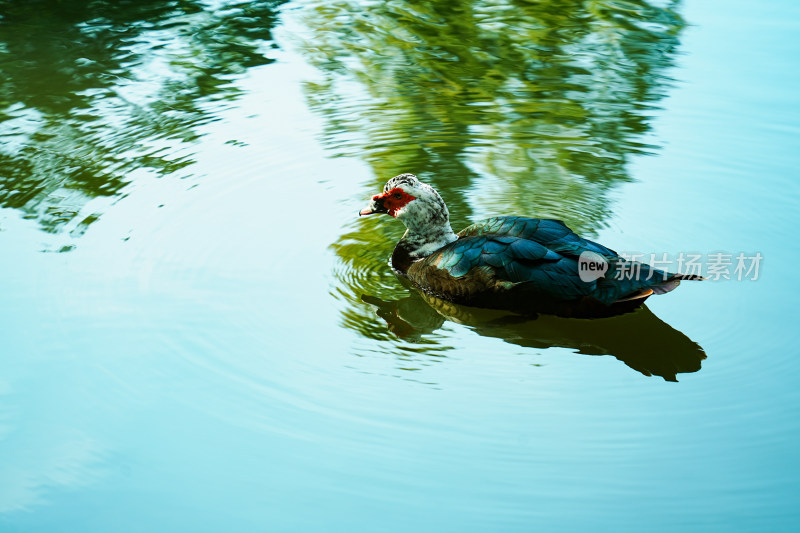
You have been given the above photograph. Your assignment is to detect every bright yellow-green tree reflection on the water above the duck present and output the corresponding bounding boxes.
[305,0,683,229]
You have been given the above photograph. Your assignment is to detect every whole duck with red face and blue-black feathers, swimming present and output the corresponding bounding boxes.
[359,173,705,318]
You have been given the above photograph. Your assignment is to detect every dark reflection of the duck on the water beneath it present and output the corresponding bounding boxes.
[361,289,706,381]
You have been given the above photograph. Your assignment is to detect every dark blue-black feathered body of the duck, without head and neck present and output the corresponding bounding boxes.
[406,216,680,316]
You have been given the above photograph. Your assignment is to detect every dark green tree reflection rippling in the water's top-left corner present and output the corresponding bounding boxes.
[0,0,282,236]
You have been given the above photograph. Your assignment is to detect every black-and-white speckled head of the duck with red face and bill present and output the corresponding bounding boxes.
[358,174,450,229]
